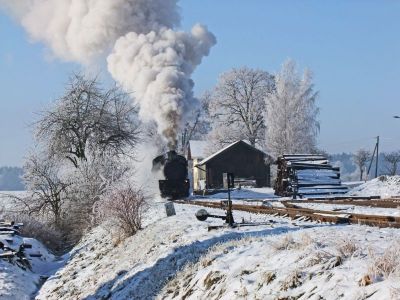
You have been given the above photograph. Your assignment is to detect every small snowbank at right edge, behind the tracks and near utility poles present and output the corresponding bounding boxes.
[348,175,400,198]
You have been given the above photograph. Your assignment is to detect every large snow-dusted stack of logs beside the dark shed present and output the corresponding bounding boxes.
[274,154,348,198]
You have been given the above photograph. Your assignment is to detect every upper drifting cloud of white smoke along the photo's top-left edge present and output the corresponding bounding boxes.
[0,0,179,64]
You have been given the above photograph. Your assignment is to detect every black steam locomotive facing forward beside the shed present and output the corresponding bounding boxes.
[152,151,190,199]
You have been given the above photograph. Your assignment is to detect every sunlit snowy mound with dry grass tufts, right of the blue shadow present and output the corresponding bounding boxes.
[158,226,400,300]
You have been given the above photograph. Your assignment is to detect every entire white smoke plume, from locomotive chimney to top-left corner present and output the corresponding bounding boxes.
[0,0,216,147]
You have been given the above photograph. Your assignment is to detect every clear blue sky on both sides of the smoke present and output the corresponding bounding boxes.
[0,0,400,165]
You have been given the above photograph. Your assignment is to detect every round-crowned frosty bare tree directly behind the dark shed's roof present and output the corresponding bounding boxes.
[208,67,274,147]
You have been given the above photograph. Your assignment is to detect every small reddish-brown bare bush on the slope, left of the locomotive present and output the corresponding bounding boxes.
[98,184,147,236]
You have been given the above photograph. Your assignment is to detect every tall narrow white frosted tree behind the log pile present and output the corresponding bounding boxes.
[264,60,319,157]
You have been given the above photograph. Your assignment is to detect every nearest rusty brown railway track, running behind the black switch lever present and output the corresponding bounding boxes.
[174,200,400,228]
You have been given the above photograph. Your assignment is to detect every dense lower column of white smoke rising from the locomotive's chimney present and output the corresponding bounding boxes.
[108,25,215,146]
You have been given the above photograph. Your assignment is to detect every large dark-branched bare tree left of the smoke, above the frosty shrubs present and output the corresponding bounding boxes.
[36,75,139,167]
